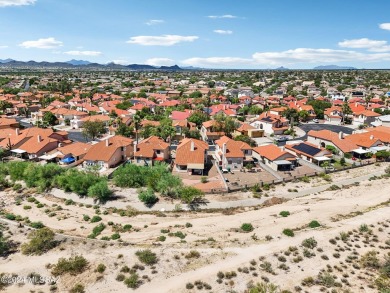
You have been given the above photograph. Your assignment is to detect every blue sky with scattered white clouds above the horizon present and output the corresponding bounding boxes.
[0,0,390,69]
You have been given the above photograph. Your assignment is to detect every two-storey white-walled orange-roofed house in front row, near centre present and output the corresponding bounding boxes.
[214,136,253,171]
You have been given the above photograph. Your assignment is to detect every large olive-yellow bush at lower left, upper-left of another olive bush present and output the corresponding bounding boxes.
[22,227,57,255]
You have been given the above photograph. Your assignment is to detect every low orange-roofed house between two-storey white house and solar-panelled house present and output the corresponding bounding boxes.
[253,144,297,171]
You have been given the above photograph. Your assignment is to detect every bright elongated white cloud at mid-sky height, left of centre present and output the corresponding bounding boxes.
[126,35,199,46]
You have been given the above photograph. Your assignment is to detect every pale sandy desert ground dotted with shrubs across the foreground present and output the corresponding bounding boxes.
[0,163,390,293]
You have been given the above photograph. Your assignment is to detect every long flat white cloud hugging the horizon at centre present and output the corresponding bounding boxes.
[182,57,254,68]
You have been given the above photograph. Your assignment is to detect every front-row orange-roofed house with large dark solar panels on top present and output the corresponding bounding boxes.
[285,142,333,165]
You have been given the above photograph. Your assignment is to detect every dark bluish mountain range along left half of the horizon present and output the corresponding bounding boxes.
[0,59,182,71]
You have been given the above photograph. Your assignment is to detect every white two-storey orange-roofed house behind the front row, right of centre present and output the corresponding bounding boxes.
[250,112,289,134]
